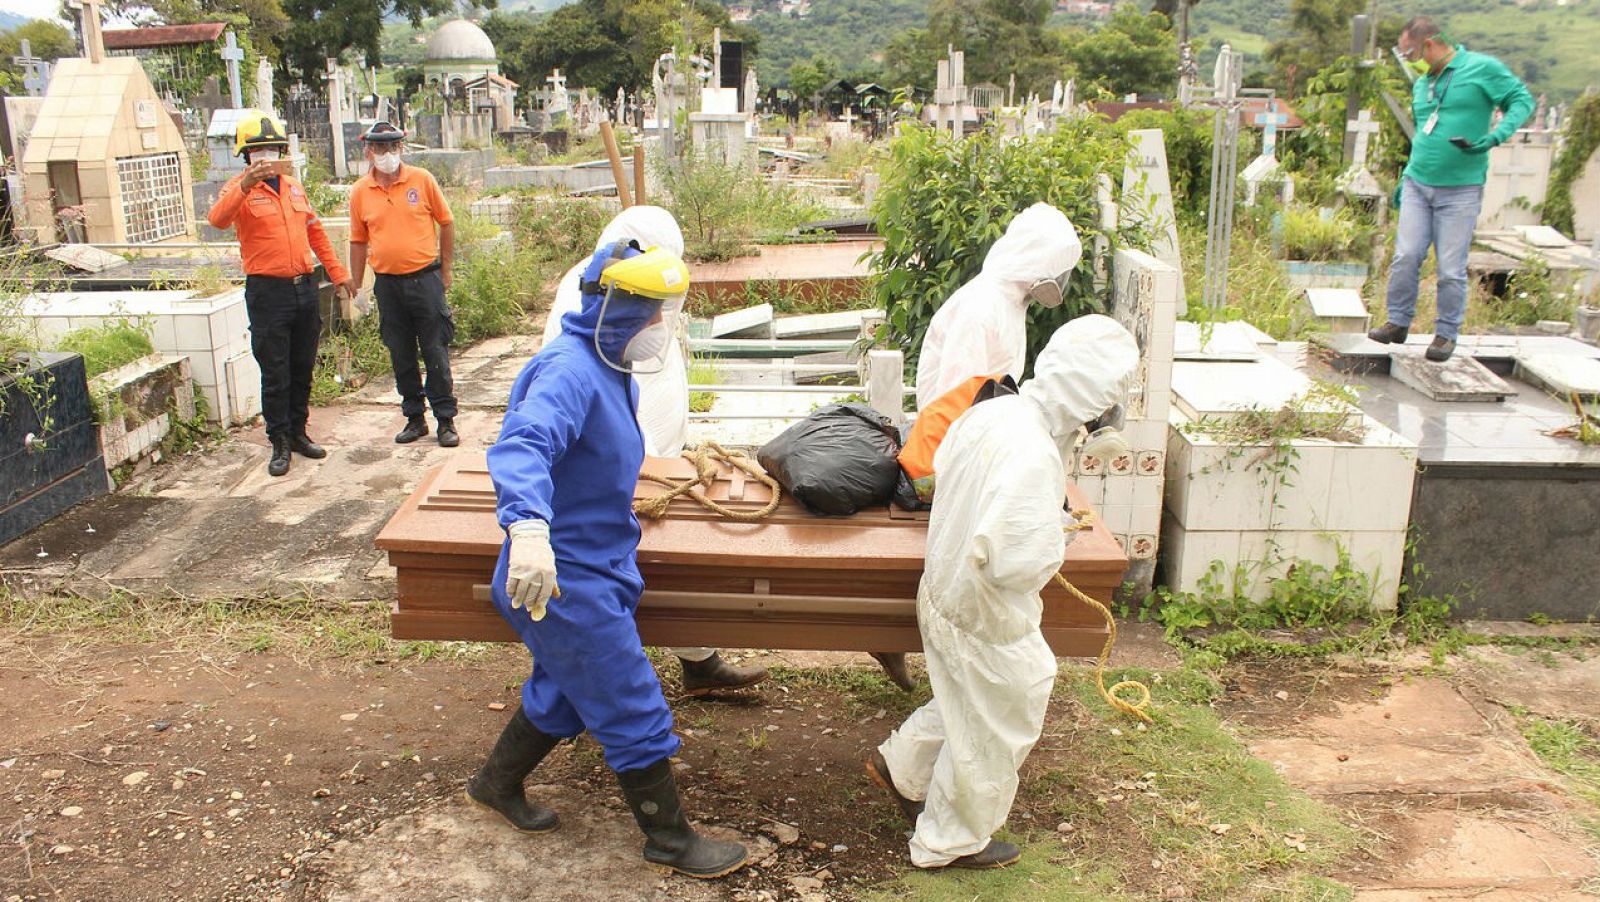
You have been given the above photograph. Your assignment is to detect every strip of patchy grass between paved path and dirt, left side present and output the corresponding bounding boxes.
[0,585,491,662]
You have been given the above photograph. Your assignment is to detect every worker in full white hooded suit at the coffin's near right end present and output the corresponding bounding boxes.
[867,315,1139,868]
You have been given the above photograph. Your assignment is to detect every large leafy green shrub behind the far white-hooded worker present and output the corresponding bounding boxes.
[872,117,1150,374]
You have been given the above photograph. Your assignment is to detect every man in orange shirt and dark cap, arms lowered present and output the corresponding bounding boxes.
[350,122,461,448]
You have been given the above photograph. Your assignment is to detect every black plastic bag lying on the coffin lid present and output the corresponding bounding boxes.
[755,405,901,517]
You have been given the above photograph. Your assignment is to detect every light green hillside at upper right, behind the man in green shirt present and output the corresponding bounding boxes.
[1189,0,1600,101]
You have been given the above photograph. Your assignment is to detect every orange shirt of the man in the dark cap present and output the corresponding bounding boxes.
[350,163,454,275]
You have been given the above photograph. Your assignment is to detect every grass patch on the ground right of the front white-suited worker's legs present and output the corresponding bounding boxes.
[867,665,1357,902]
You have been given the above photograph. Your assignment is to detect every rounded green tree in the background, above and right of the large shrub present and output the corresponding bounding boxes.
[1067,3,1178,96]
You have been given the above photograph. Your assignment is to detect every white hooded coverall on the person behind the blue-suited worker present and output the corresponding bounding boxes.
[544,206,690,457]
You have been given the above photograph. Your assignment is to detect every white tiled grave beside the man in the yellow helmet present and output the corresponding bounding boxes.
[19,288,261,425]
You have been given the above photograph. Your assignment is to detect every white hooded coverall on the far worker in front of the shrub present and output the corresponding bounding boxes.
[917,203,1099,413]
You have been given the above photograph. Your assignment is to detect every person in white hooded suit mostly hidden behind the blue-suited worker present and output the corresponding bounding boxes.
[544,205,766,696]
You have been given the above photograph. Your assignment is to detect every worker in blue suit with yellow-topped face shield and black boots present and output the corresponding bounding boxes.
[467,241,746,878]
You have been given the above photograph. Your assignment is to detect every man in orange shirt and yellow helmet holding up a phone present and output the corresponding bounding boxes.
[206,110,355,477]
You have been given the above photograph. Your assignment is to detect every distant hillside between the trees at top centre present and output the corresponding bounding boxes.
[739,0,928,88]
